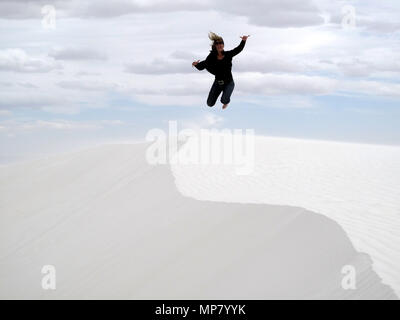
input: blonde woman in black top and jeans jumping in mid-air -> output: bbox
[192,32,250,109]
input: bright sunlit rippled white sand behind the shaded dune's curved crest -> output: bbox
[172,137,400,295]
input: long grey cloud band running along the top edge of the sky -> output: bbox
[0,0,323,28]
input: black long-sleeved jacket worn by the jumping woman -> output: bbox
[195,40,246,82]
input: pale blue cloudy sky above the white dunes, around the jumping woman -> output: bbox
[0,0,400,162]
